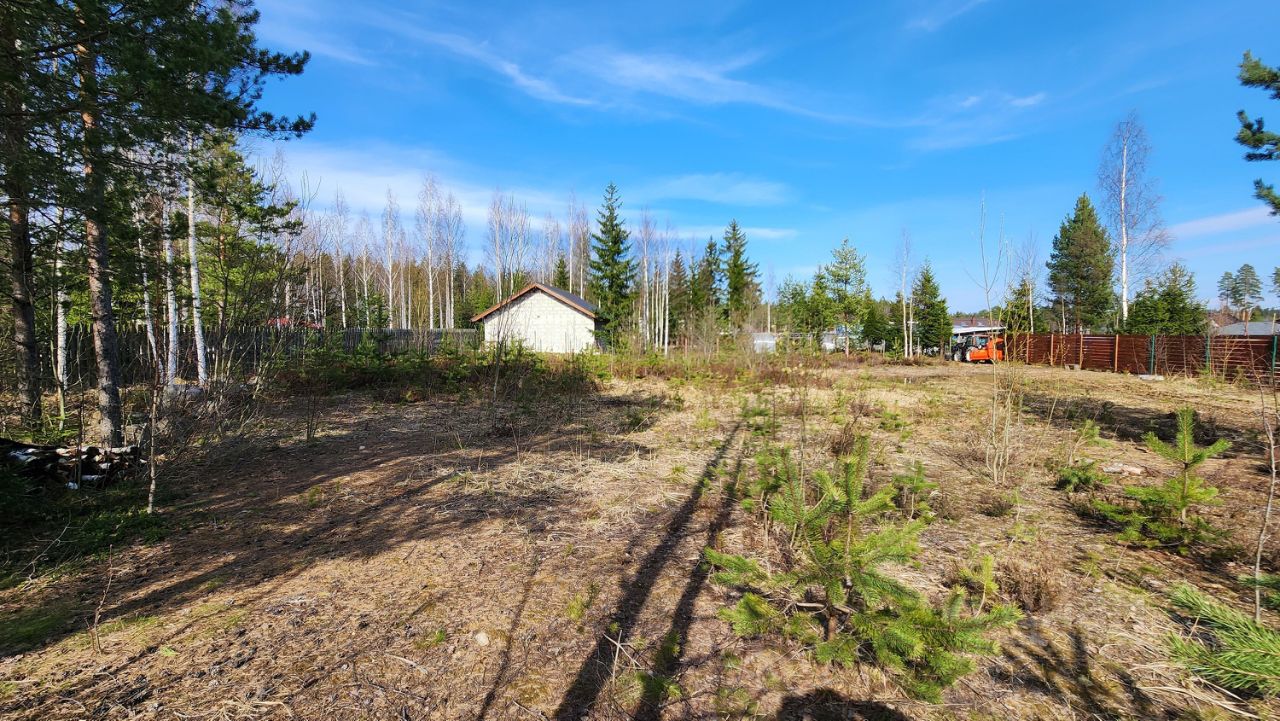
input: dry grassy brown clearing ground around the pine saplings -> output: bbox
[0,364,1280,720]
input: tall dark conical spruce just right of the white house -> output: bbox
[590,183,635,343]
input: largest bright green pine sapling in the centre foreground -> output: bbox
[704,438,1020,701]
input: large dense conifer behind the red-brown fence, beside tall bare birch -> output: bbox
[1047,193,1115,333]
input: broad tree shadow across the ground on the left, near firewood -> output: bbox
[0,386,675,713]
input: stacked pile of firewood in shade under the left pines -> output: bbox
[0,438,146,489]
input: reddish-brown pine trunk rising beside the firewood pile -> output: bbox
[76,29,124,446]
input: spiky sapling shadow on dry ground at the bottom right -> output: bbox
[992,620,1161,720]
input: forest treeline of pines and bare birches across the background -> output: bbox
[0,0,1280,444]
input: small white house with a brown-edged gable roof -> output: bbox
[471,283,596,353]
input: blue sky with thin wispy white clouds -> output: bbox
[259,0,1280,309]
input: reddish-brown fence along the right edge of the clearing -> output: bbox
[1006,333,1280,384]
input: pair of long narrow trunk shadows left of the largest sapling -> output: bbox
[553,421,742,721]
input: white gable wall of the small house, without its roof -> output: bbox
[484,288,595,353]
